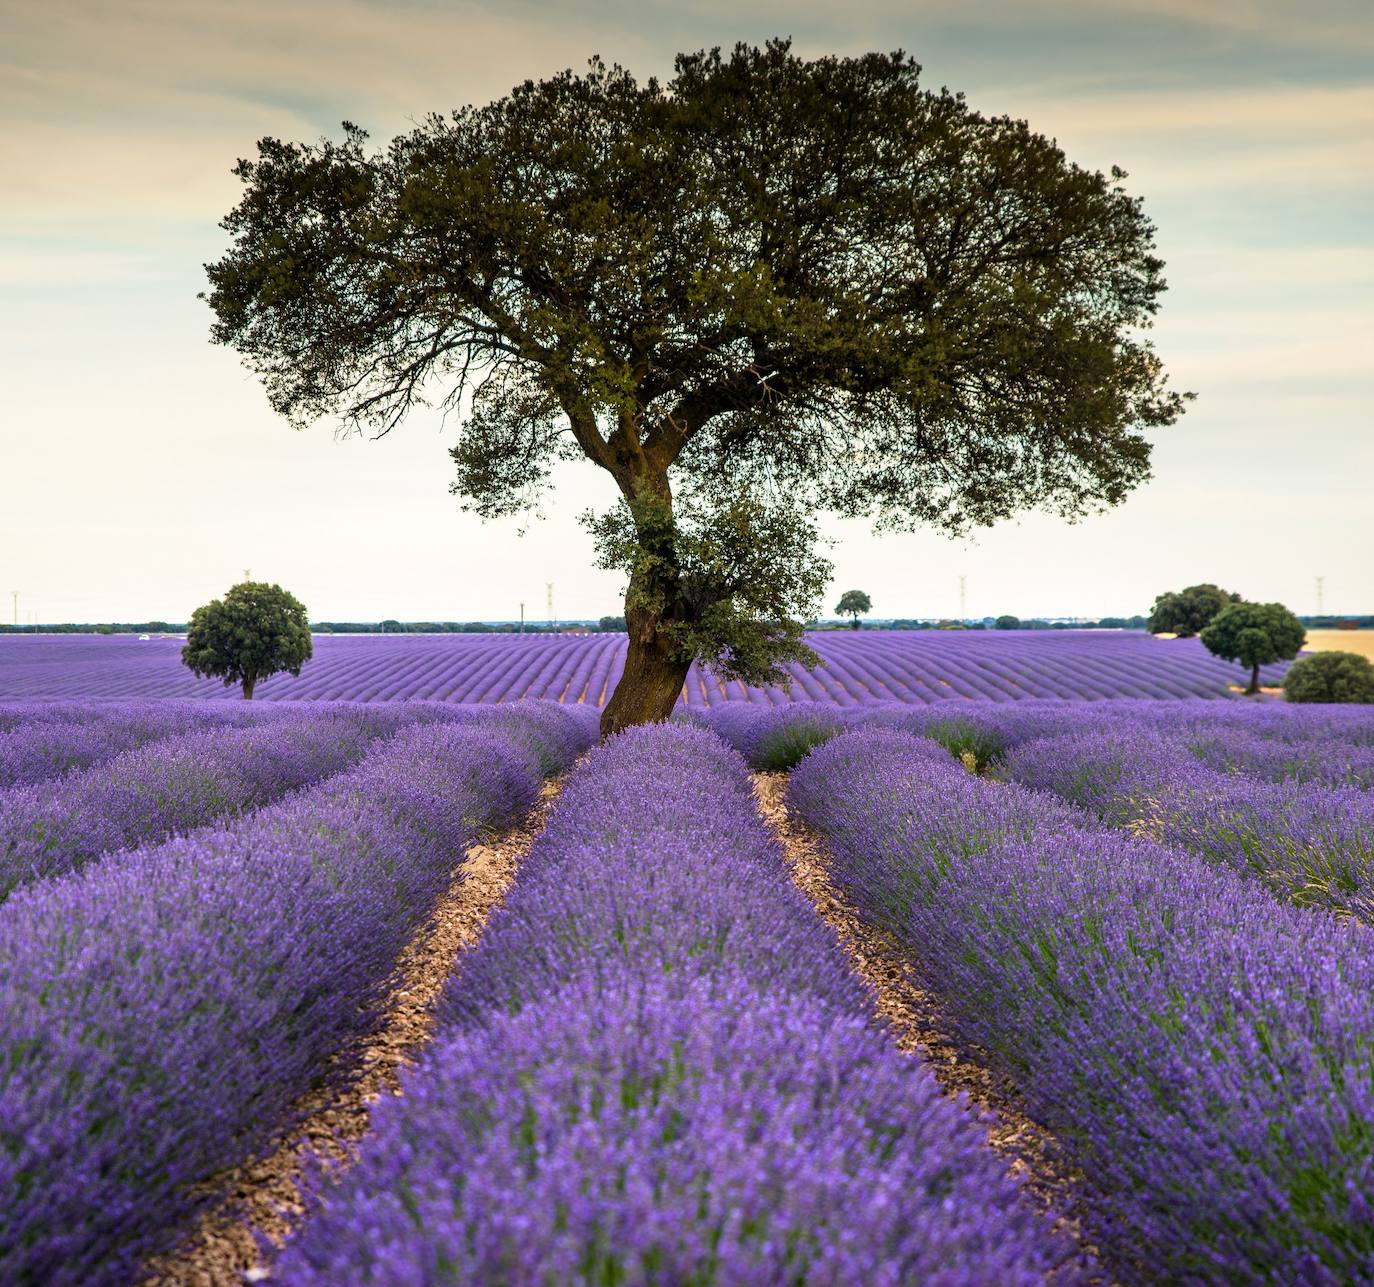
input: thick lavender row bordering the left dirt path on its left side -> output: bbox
[0,707,594,1284]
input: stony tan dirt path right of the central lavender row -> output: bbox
[752,773,1109,1283]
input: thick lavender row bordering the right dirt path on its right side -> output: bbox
[790,729,1374,1283]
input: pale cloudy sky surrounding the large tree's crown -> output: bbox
[0,0,1374,622]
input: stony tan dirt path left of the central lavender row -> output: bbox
[143,775,566,1287]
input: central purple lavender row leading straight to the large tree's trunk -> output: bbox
[265,727,1073,1287]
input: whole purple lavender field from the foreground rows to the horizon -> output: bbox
[0,678,1374,1287]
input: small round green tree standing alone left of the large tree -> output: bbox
[181,581,313,701]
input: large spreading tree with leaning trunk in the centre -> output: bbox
[206,40,1184,732]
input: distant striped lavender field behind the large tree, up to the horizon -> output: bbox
[0,630,1286,706]
